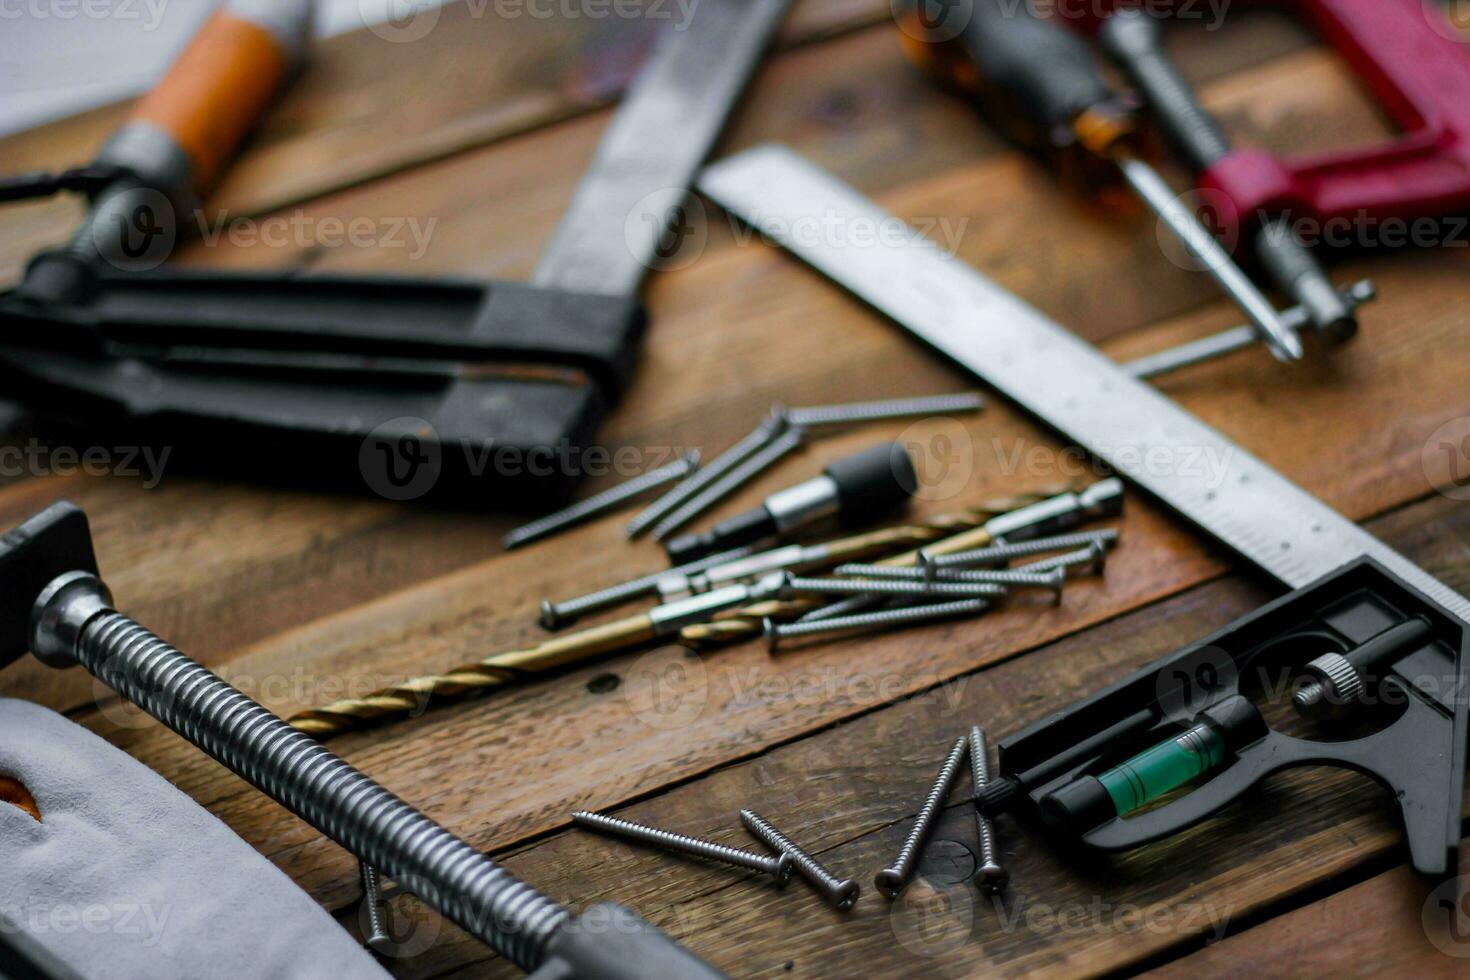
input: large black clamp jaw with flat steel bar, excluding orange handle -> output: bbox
[0,0,785,505]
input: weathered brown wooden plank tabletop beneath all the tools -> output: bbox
[0,0,1470,977]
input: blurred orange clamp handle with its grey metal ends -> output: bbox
[0,0,313,268]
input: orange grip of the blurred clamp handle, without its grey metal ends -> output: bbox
[131,4,309,192]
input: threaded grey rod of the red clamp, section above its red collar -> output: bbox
[1098,10,1230,170]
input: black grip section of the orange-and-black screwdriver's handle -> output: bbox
[957,0,1113,143]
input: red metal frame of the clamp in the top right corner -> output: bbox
[1200,0,1470,235]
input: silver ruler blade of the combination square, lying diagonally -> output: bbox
[698,145,1470,621]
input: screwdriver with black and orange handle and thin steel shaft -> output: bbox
[900,0,1302,361]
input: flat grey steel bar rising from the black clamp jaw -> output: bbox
[531,0,786,295]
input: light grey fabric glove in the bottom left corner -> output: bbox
[0,699,388,980]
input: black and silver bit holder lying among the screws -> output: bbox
[666,442,919,564]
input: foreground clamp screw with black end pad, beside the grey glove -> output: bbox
[0,502,723,980]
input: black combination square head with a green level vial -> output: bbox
[979,557,1470,879]
